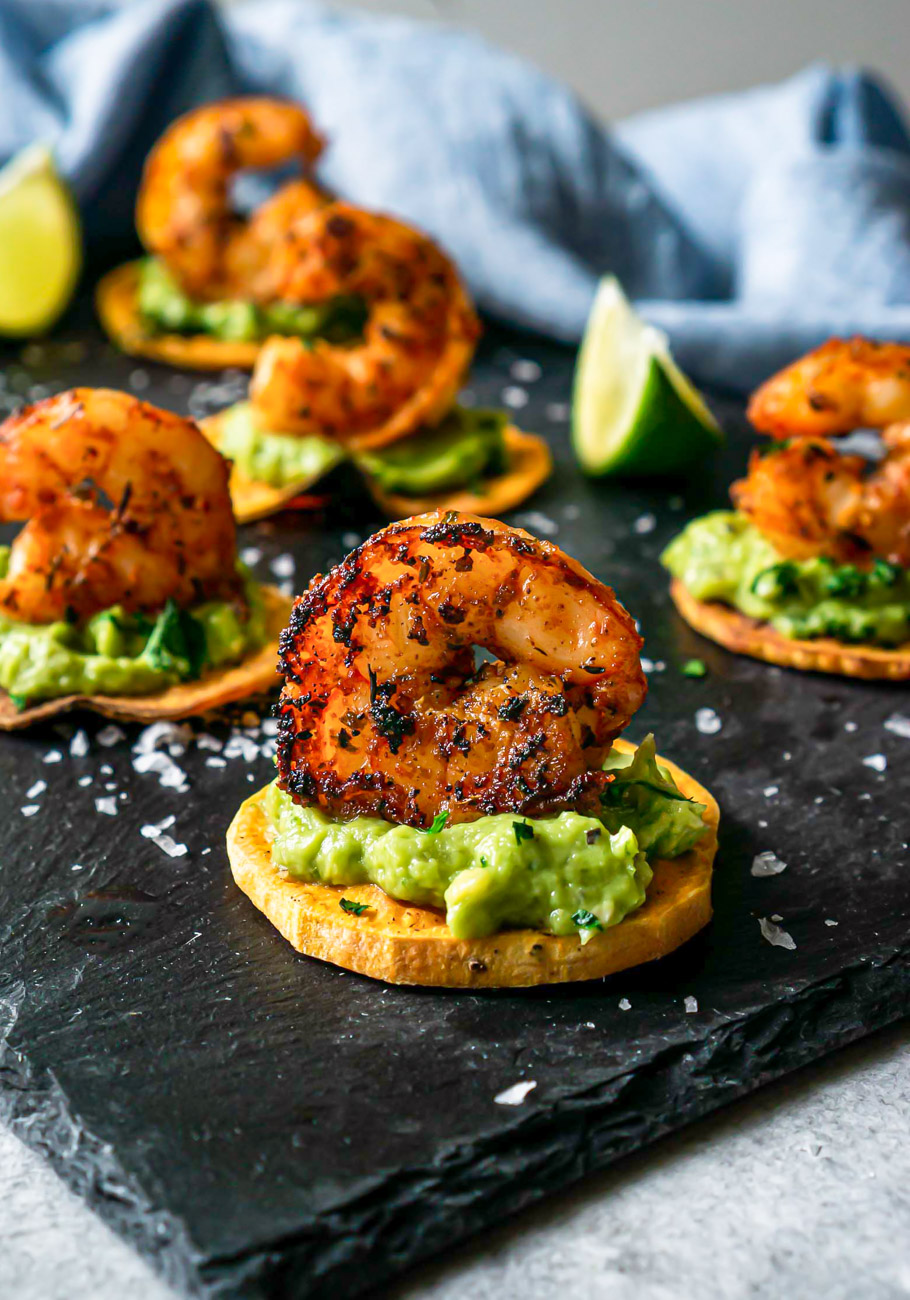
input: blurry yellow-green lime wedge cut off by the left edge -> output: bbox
[0,144,82,335]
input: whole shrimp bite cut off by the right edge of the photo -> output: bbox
[663,338,910,680]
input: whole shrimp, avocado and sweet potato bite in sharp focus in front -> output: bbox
[228,511,719,988]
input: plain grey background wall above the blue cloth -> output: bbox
[314,0,910,118]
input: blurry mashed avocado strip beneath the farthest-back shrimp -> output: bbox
[139,257,365,343]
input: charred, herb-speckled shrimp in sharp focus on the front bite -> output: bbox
[278,511,647,828]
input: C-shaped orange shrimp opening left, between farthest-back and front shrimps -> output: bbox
[250,203,478,447]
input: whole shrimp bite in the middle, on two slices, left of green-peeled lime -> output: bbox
[203,203,551,523]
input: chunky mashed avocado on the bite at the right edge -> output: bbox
[662,510,910,646]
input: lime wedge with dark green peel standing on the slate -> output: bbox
[572,276,722,476]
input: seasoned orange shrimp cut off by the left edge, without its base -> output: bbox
[0,389,239,623]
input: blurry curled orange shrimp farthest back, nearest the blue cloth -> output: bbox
[137,98,325,302]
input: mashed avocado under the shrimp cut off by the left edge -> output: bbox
[0,546,268,709]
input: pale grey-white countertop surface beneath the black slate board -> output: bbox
[0,1023,910,1300]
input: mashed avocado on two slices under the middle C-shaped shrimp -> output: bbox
[218,402,507,495]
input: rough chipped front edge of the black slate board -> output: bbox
[0,948,910,1300]
